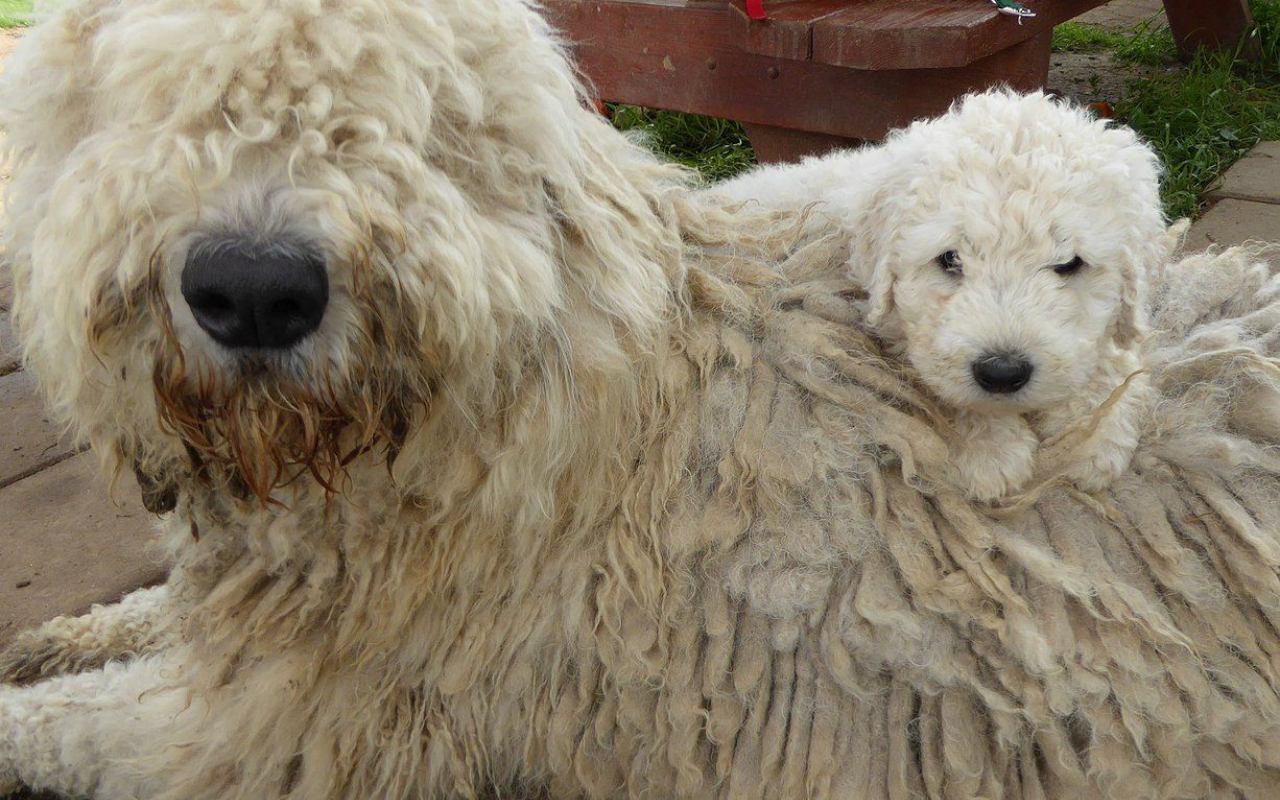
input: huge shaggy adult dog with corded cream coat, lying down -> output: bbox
[0,0,1280,800]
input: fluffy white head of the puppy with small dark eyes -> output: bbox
[854,91,1166,412]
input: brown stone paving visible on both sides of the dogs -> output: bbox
[0,6,1280,645]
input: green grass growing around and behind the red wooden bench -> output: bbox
[613,0,1280,219]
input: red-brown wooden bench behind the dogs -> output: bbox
[543,0,1253,161]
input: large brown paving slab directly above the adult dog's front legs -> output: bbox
[0,453,165,645]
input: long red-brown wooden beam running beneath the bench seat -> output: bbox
[545,0,1048,140]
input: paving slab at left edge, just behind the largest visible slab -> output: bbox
[0,371,73,486]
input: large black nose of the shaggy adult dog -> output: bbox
[182,248,329,348]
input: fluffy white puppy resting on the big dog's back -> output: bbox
[709,91,1169,499]
